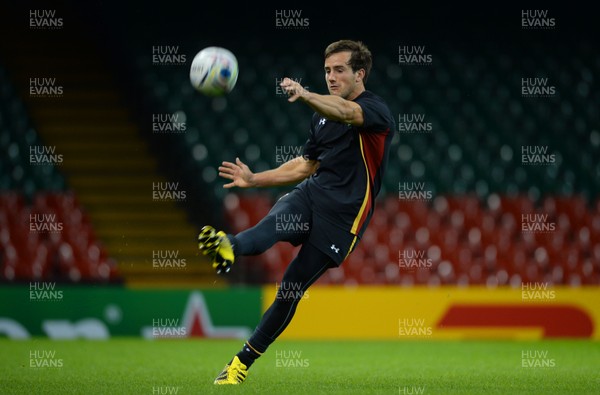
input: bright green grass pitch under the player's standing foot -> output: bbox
[0,338,600,395]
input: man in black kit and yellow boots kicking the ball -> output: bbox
[198,40,395,384]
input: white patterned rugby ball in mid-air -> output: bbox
[190,47,238,96]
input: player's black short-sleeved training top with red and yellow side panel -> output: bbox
[298,91,395,238]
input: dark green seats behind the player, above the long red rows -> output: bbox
[124,34,599,199]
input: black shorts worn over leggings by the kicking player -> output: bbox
[267,188,358,266]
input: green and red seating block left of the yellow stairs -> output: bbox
[0,63,121,283]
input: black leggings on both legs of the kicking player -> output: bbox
[229,192,336,353]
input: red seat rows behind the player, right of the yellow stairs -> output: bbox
[225,194,600,287]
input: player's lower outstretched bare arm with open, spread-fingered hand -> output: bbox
[219,157,319,188]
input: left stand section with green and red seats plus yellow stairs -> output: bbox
[0,4,214,285]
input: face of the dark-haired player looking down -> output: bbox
[325,51,359,99]
